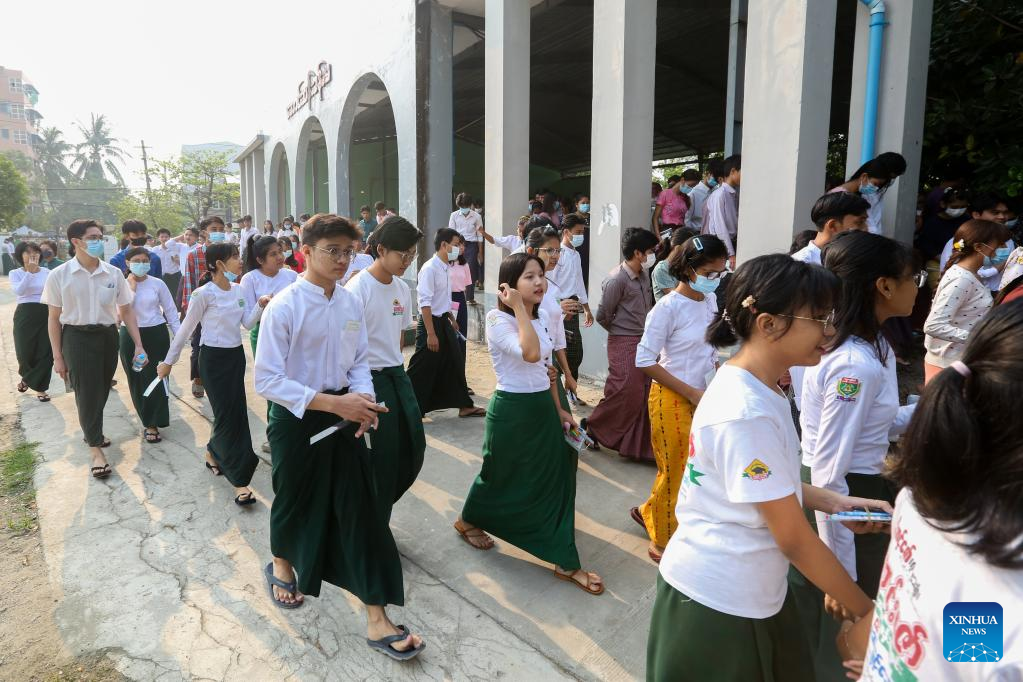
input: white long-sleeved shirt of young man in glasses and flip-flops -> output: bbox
[255,277,375,419]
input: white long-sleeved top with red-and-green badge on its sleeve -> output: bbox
[799,336,916,580]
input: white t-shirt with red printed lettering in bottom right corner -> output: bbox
[860,490,1023,682]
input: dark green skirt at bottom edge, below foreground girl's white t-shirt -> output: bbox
[647,573,814,682]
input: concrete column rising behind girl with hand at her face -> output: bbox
[477,0,530,300]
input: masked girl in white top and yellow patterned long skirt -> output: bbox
[630,236,728,562]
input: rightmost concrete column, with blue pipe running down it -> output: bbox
[845,0,934,242]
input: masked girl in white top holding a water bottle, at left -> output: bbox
[120,246,180,443]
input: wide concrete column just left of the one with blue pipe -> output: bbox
[738,0,836,261]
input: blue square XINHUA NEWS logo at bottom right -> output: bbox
[941,601,1005,663]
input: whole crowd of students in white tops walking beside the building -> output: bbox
[3,152,1023,680]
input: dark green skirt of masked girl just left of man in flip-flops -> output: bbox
[198,346,259,488]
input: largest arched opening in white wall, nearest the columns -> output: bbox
[335,72,400,216]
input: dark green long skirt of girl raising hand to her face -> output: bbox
[461,391,580,571]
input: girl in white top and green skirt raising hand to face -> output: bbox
[454,253,604,595]
